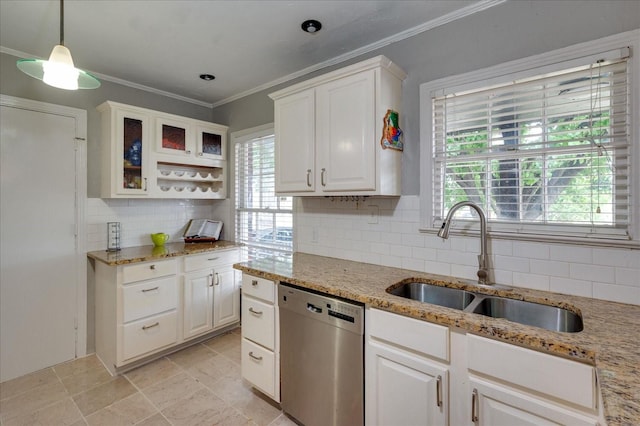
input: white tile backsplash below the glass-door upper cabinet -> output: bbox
[87,198,215,251]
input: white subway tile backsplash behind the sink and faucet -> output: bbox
[294,196,640,305]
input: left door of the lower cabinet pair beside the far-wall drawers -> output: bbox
[184,270,214,339]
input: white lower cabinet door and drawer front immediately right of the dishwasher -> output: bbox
[365,309,449,425]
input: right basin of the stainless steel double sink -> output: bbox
[469,296,583,333]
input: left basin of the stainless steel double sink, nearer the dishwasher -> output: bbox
[387,282,475,310]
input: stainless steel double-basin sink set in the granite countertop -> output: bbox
[387,282,583,333]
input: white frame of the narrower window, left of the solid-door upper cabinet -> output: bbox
[229,123,295,260]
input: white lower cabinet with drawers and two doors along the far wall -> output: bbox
[95,249,240,374]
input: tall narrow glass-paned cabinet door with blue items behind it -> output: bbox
[112,109,151,195]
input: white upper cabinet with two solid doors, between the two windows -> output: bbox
[270,56,405,196]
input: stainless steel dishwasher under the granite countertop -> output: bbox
[278,283,364,426]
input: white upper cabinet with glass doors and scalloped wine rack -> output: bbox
[98,101,227,199]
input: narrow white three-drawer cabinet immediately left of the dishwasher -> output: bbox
[241,274,280,402]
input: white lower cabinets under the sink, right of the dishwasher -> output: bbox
[365,308,605,426]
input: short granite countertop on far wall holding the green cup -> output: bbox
[87,241,242,266]
